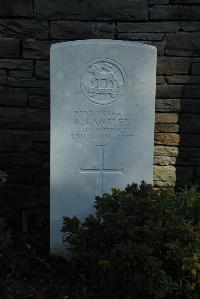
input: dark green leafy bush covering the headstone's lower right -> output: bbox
[63,182,200,299]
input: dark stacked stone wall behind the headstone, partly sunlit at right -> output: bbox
[0,0,200,237]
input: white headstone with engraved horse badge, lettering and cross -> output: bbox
[50,40,156,254]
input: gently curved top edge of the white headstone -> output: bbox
[50,39,157,52]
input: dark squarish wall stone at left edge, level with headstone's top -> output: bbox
[0,38,20,58]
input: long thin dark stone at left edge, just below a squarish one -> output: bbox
[0,59,33,71]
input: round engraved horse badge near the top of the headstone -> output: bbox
[81,59,126,105]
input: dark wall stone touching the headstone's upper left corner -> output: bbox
[23,39,51,59]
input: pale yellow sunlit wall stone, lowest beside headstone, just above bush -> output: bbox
[154,165,176,186]
